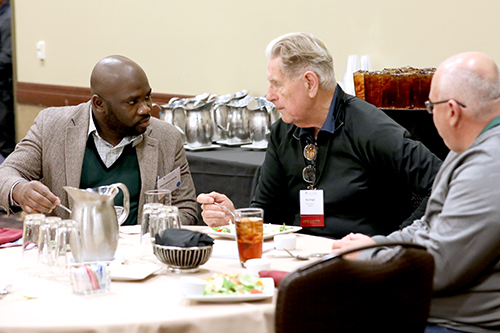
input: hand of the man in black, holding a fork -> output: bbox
[196,192,234,227]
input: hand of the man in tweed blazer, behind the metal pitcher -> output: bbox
[12,180,61,214]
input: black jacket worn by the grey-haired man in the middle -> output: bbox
[251,87,441,238]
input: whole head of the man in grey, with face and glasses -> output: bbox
[429,52,500,154]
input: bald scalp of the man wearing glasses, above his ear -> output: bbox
[433,52,500,118]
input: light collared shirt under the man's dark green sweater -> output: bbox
[88,106,144,168]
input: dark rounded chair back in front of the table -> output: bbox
[275,243,434,333]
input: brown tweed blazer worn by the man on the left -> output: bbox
[0,101,197,224]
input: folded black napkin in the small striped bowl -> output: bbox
[155,229,214,247]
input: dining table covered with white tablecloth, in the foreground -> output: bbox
[0,226,333,333]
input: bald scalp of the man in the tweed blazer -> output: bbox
[90,55,147,99]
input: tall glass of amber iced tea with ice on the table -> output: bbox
[235,208,264,267]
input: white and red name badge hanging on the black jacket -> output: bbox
[300,190,325,227]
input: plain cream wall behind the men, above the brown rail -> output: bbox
[13,0,500,96]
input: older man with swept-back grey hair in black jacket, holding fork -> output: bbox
[198,33,441,238]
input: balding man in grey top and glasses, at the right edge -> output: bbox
[333,52,500,333]
